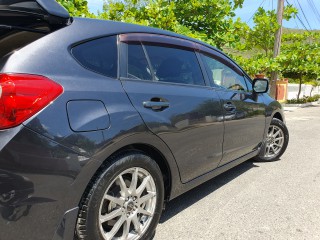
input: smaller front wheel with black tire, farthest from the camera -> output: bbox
[254,118,289,162]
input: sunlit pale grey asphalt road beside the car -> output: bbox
[155,106,320,240]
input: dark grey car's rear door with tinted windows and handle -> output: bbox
[120,34,223,182]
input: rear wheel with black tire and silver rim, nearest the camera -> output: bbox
[75,151,164,240]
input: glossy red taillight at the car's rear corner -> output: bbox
[0,74,63,129]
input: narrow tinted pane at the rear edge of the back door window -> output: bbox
[127,43,152,80]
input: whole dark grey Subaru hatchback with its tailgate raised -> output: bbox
[0,0,289,240]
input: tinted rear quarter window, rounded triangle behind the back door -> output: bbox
[72,36,118,78]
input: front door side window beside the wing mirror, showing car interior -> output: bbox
[201,54,248,91]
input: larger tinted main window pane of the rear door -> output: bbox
[145,45,205,86]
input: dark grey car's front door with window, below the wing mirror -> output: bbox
[201,50,266,166]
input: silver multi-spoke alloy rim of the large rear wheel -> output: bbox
[99,167,157,240]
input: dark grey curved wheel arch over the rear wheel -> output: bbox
[71,133,181,213]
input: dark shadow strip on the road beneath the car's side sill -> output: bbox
[160,160,259,223]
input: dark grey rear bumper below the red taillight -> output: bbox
[0,127,91,240]
